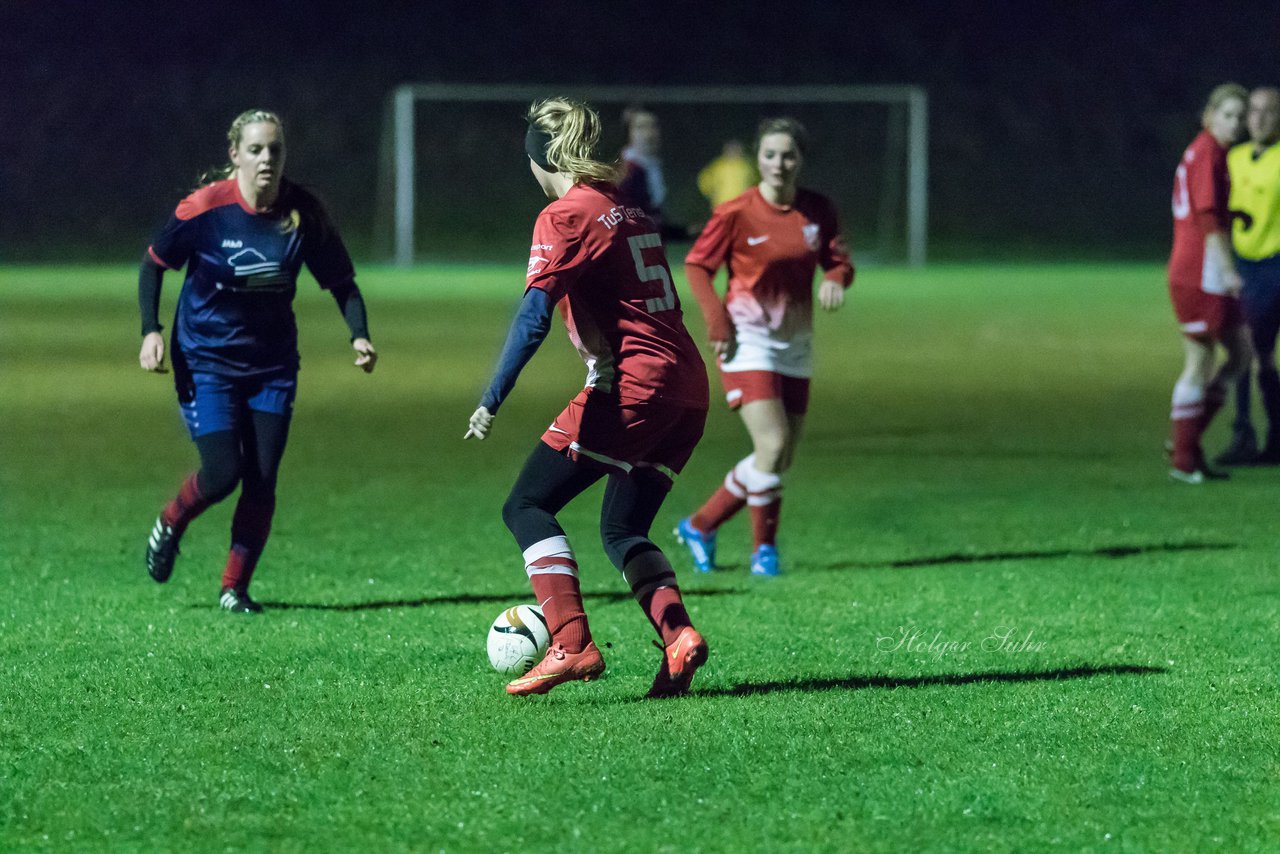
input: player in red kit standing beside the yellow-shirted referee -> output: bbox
[1169,83,1252,484]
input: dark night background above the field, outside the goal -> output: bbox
[0,0,1280,262]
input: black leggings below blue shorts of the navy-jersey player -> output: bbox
[196,411,289,503]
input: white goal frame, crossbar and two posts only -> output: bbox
[392,83,928,266]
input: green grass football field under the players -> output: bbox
[0,264,1280,851]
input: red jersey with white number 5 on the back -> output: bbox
[526,183,708,408]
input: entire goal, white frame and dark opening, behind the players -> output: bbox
[375,83,928,266]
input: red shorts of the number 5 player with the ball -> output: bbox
[543,388,707,480]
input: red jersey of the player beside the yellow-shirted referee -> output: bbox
[1169,131,1231,293]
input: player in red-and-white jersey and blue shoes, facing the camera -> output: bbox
[676,118,854,575]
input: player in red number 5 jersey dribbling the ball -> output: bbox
[463,99,707,697]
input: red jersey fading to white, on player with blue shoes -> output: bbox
[685,187,854,368]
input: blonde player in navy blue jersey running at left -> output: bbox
[138,110,378,613]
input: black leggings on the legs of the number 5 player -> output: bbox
[502,442,671,571]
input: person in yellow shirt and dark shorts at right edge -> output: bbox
[1217,86,1280,466]
